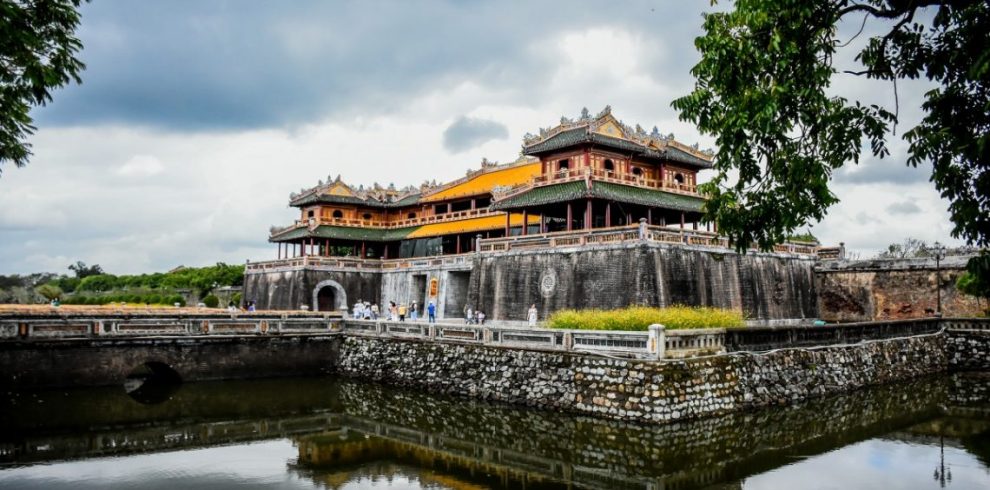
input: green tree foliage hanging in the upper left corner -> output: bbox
[0,0,85,171]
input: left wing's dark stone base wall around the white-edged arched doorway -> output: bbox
[243,269,382,310]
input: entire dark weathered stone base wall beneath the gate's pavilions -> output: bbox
[244,243,818,321]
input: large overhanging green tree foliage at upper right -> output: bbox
[673,0,990,249]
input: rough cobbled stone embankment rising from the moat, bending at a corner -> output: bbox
[338,335,946,422]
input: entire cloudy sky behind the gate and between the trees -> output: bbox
[0,0,954,274]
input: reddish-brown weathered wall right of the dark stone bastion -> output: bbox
[815,257,980,322]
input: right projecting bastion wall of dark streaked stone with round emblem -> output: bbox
[468,243,818,320]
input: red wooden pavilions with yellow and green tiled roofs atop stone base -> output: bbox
[269,107,712,259]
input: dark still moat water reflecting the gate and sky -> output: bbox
[0,375,990,490]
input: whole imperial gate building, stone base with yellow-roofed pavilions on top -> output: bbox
[244,107,843,320]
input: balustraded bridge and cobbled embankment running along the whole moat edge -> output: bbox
[0,315,990,423]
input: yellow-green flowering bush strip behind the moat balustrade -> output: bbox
[547,306,746,331]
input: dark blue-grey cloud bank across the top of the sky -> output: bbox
[27,0,684,130]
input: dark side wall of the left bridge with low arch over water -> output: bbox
[0,334,340,388]
